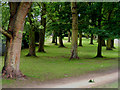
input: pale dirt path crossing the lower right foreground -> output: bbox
[19,69,118,88]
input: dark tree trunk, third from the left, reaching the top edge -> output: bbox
[38,3,46,52]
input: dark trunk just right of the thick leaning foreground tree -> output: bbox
[27,9,36,56]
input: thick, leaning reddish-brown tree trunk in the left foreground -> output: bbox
[2,2,31,78]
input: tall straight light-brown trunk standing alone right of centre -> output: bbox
[70,2,78,59]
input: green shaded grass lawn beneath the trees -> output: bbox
[0,38,118,85]
